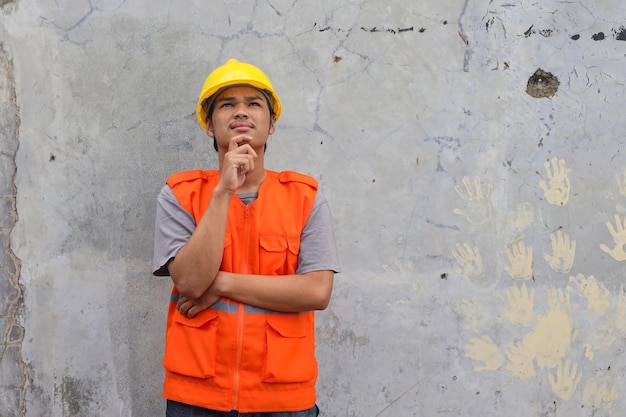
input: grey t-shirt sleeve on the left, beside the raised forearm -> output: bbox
[152,185,196,276]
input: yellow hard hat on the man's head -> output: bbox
[196,58,282,129]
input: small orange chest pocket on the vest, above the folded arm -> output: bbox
[259,234,300,275]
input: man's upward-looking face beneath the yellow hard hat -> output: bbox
[207,86,274,149]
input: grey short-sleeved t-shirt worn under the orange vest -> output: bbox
[152,185,341,276]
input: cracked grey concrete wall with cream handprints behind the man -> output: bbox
[0,0,626,417]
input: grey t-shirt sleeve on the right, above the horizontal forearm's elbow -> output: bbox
[297,190,341,274]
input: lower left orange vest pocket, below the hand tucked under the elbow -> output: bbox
[163,310,217,378]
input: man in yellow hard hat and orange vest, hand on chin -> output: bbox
[153,59,339,417]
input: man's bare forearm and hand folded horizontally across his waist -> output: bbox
[177,270,335,317]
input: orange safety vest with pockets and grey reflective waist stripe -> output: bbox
[163,170,317,413]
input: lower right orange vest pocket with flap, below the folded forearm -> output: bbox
[263,313,317,383]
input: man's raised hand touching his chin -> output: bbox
[220,135,257,193]
